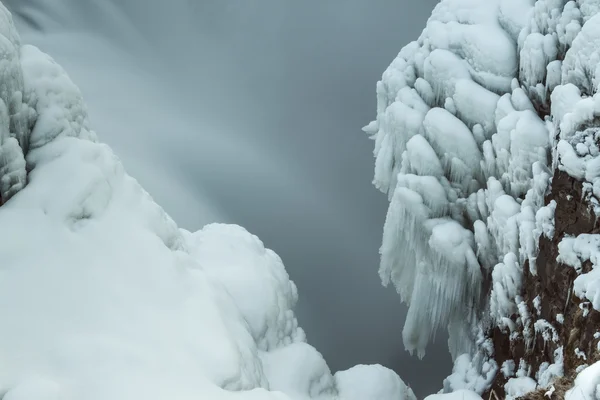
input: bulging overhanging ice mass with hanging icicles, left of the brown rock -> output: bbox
[365,0,556,357]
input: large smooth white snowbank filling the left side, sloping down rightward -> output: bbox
[0,4,414,400]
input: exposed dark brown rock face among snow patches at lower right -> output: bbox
[484,170,600,398]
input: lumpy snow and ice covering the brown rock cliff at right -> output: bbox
[364,0,600,398]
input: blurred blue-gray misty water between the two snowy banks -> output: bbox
[4,0,451,395]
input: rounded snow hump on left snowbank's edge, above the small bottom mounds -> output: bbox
[186,225,305,351]
